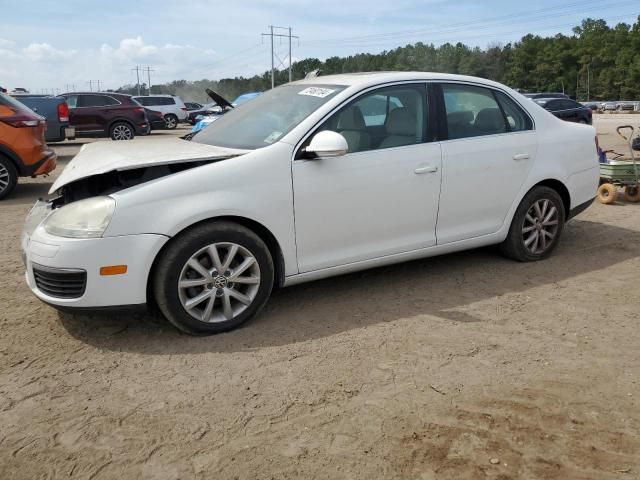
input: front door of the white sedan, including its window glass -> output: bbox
[292,83,441,273]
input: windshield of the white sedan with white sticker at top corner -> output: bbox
[192,85,346,150]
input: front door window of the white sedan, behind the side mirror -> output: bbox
[318,84,427,153]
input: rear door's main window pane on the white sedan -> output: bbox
[442,84,507,139]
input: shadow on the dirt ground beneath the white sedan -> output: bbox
[60,220,640,354]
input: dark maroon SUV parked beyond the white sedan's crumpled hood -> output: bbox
[62,92,149,140]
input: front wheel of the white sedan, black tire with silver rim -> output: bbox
[156,222,274,335]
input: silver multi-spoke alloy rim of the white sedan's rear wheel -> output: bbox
[522,199,560,255]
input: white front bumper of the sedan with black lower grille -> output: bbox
[21,201,169,311]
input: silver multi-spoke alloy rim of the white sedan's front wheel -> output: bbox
[178,242,260,323]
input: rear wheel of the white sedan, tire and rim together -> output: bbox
[500,186,566,262]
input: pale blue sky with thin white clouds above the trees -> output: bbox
[0,0,640,93]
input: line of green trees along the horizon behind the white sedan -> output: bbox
[118,15,640,102]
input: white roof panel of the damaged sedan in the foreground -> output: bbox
[290,72,504,88]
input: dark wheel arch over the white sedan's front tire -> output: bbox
[147,215,285,303]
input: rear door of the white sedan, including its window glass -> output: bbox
[436,83,537,244]
